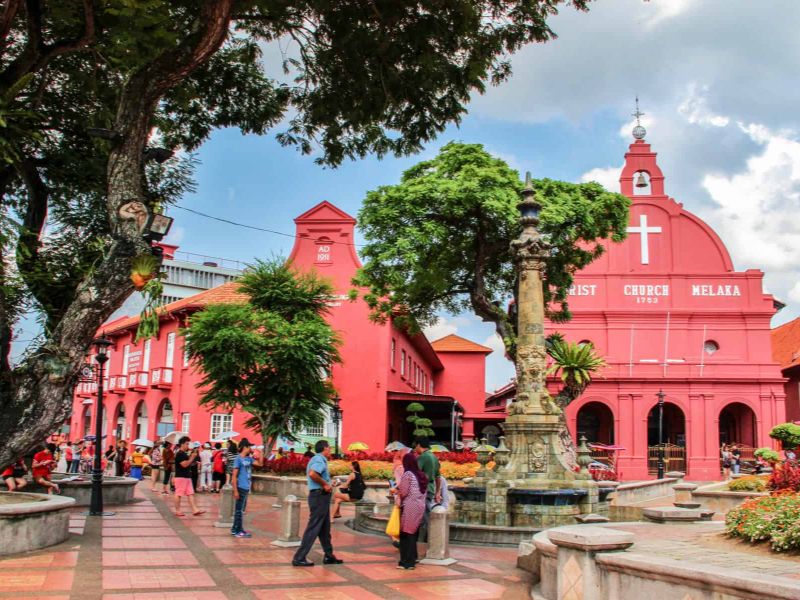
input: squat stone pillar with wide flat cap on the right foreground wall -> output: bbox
[548,525,634,600]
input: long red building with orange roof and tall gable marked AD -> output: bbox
[70,202,492,449]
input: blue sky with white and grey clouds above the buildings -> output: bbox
[25,0,800,390]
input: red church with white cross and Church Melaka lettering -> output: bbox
[484,132,786,480]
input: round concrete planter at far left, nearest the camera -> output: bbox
[0,492,75,556]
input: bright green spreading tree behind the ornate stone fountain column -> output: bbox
[354,142,630,359]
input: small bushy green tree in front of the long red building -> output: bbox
[184,260,341,448]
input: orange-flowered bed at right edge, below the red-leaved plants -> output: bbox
[725,491,800,552]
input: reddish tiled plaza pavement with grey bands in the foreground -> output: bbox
[0,484,530,600]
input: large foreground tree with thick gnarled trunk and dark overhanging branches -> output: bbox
[0,0,587,464]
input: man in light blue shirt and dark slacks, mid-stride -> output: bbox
[292,440,344,567]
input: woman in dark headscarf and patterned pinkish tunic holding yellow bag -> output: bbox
[392,453,424,571]
